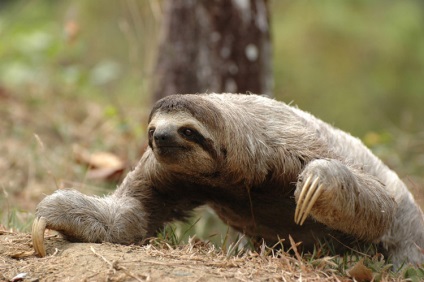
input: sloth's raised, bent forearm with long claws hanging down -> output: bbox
[294,159,397,241]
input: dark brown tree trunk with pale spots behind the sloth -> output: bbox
[154,0,273,100]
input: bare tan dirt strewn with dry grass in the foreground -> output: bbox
[0,231,349,281]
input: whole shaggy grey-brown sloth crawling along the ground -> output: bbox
[33,94,424,265]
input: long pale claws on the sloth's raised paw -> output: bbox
[294,177,323,225]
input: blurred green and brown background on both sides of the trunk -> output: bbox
[0,0,424,238]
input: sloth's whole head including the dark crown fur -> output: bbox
[148,95,225,176]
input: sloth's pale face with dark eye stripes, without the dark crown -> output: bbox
[148,111,217,176]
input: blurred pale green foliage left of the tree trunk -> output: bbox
[0,0,157,102]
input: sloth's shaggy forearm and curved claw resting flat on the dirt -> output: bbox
[32,190,146,256]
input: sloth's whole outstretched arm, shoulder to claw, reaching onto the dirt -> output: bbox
[32,153,198,256]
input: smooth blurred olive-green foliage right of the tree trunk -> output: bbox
[272,0,424,137]
